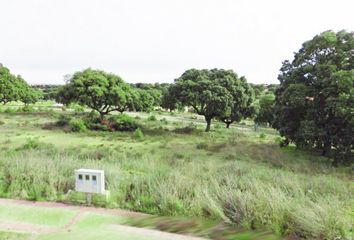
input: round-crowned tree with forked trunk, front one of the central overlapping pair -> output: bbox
[171,69,233,132]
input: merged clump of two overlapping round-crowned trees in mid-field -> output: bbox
[170,69,253,131]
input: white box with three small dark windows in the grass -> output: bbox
[75,168,106,194]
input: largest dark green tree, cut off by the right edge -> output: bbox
[274,31,354,164]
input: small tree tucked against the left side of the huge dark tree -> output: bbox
[255,93,275,126]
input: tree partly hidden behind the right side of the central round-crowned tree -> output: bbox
[218,75,254,128]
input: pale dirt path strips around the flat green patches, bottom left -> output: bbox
[0,198,202,240]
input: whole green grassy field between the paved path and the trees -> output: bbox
[0,102,354,239]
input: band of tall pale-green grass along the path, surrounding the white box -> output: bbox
[0,141,354,239]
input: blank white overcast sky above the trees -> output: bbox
[0,0,354,84]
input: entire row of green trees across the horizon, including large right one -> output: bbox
[0,31,354,164]
